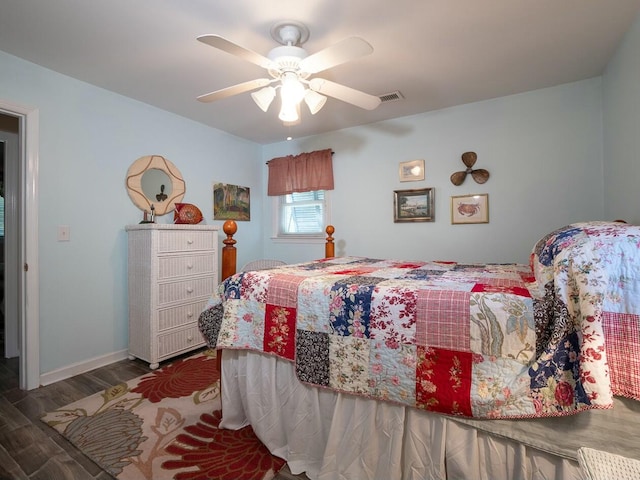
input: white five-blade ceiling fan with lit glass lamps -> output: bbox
[197,20,381,125]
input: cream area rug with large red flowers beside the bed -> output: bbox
[42,350,285,480]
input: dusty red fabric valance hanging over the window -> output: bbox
[267,149,333,196]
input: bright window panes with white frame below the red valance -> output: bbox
[275,190,329,238]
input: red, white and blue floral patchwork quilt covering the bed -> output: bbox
[200,222,640,418]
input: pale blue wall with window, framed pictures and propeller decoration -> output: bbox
[263,78,604,263]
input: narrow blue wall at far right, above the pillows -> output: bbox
[603,10,640,221]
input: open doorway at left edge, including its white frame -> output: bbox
[0,100,40,390]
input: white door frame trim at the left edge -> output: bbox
[0,99,40,390]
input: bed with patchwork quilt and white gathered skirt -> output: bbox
[199,222,640,479]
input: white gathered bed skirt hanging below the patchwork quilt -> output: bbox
[220,350,582,480]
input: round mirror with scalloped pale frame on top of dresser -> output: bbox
[125,155,186,215]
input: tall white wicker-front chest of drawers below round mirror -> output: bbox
[125,223,218,369]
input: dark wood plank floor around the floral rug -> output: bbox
[0,338,307,480]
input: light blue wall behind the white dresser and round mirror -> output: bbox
[0,52,262,373]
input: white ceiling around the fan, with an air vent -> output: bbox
[0,0,640,144]
